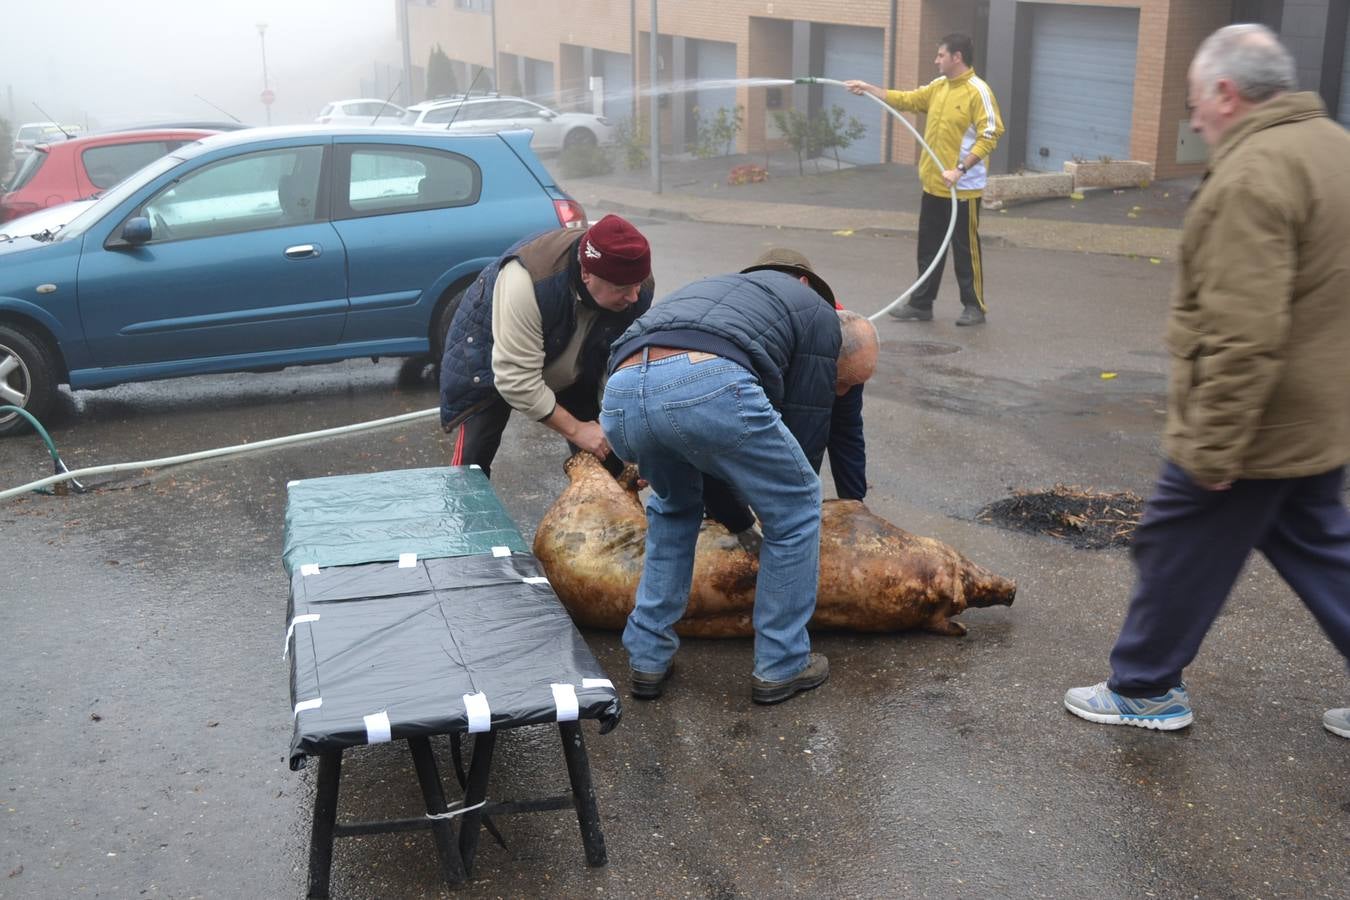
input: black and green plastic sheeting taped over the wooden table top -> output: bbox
[286,470,621,769]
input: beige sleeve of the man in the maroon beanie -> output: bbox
[493,259,556,422]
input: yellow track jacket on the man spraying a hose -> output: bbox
[886,69,1003,200]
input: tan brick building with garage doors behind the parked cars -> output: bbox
[396,0,1350,178]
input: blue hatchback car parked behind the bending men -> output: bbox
[0,127,586,434]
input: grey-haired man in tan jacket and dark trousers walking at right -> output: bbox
[1064,24,1350,738]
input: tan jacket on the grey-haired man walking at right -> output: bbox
[1164,93,1350,483]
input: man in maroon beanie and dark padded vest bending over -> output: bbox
[440,216,655,475]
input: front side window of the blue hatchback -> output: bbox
[142,147,324,242]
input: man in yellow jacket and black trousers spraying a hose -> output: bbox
[844,34,1003,325]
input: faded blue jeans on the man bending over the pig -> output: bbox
[599,355,821,681]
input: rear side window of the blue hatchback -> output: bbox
[344,146,482,219]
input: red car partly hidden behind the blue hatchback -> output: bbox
[0,128,216,223]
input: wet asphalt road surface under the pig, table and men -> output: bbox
[0,219,1350,899]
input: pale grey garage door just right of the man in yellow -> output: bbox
[1025,4,1139,171]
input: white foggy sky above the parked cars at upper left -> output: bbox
[0,0,400,128]
